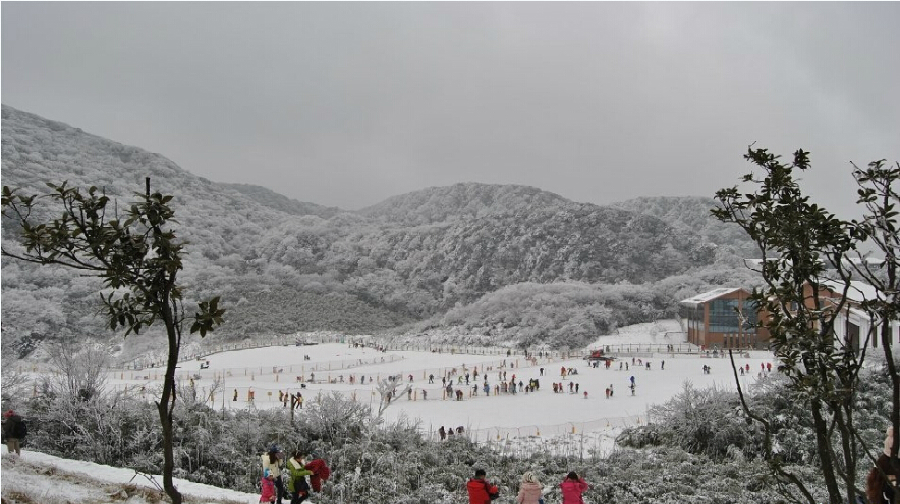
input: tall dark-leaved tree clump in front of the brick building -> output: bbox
[712,147,900,504]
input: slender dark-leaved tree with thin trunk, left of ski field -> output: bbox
[2,178,224,504]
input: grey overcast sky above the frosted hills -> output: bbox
[0,2,900,216]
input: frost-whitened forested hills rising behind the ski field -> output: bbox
[2,106,752,354]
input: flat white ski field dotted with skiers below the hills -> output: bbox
[98,320,774,441]
